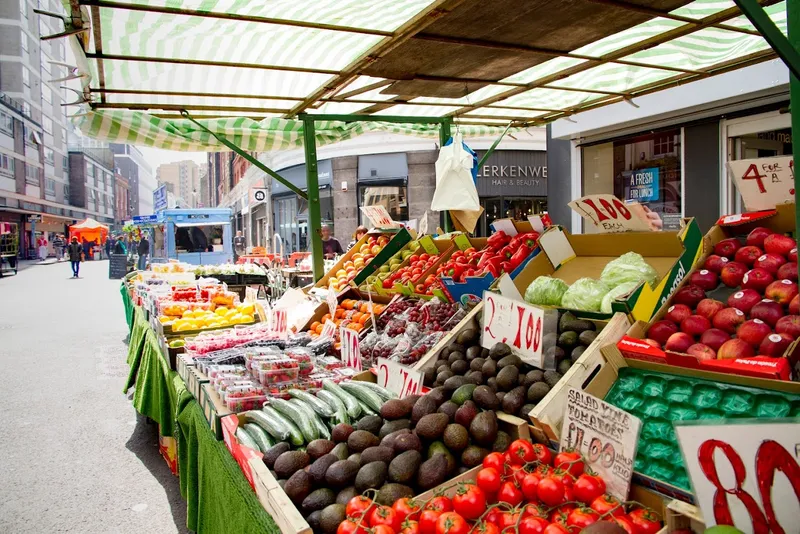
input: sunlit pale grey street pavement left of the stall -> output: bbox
[0,261,188,534]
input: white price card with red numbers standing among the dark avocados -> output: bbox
[481,291,544,367]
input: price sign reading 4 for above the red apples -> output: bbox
[728,156,794,211]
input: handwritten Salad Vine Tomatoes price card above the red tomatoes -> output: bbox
[560,387,642,501]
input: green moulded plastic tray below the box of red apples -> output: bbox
[605,367,800,492]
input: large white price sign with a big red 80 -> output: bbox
[675,419,800,533]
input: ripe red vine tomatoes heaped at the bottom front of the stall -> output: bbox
[340,450,662,534]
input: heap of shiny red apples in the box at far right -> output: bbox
[647,224,800,366]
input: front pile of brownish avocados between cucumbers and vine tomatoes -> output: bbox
[264,382,512,534]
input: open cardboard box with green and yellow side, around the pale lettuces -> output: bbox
[510,219,704,321]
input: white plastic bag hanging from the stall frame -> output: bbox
[431,132,481,211]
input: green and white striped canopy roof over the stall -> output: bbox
[62,0,787,151]
